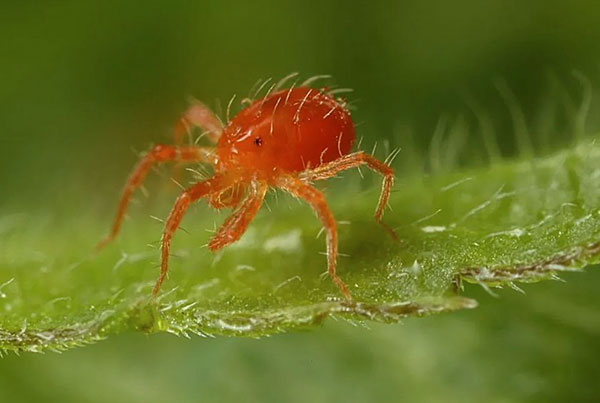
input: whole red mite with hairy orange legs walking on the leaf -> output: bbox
[99,80,395,299]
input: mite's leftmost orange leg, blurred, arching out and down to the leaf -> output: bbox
[97,145,216,249]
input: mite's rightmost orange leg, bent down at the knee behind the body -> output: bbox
[300,151,398,240]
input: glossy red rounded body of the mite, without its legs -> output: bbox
[217,88,354,174]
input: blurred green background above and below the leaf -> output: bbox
[0,0,600,402]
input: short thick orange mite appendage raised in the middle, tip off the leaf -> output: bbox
[208,181,268,251]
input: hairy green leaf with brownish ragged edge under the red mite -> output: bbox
[0,143,600,351]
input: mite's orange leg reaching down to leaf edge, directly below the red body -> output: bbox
[278,176,352,300]
